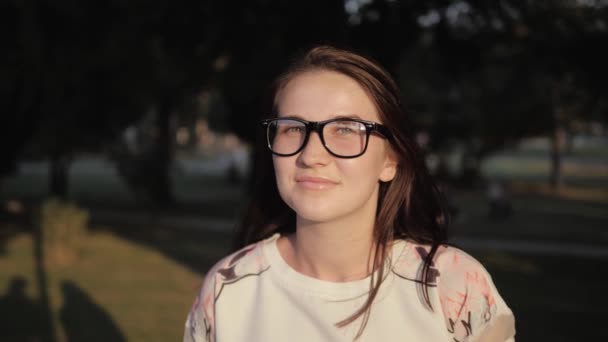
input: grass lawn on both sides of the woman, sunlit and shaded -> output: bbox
[0,198,608,342]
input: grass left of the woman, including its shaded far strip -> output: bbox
[0,224,233,342]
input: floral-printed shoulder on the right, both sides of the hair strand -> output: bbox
[393,240,515,342]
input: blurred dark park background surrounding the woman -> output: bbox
[0,0,608,342]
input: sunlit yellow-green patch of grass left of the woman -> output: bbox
[0,231,214,341]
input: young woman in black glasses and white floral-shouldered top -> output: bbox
[184,46,515,342]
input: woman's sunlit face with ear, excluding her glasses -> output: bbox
[273,71,396,222]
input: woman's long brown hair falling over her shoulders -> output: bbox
[235,46,448,339]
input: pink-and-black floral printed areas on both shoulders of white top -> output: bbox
[184,240,515,342]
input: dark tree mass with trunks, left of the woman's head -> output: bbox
[2,1,224,203]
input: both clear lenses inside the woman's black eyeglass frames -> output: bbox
[268,119,367,157]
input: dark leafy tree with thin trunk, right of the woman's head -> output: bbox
[354,0,608,186]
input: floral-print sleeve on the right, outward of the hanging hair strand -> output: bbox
[436,247,515,342]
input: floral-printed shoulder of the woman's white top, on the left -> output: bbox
[184,236,269,341]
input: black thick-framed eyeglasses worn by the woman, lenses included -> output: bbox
[261,117,391,158]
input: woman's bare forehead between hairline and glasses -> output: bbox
[277,70,379,121]
